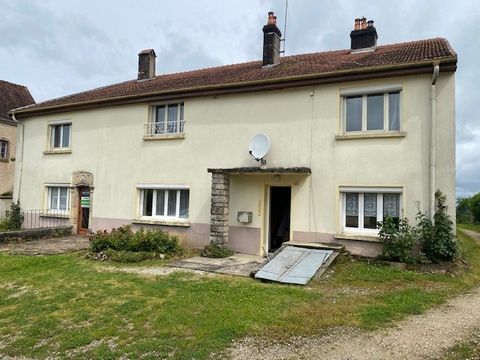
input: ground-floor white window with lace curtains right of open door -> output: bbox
[340,188,402,236]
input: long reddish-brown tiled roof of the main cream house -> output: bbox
[14,38,456,114]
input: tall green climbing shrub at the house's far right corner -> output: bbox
[417,190,457,263]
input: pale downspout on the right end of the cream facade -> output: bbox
[430,62,440,221]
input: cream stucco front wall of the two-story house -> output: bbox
[16,74,455,253]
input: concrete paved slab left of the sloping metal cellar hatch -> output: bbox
[169,254,265,276]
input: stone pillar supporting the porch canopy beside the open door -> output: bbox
[210,172,230,245]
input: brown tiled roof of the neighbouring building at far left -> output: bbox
[0,80,35,124]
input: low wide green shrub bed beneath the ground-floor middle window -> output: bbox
[90,225,183,255]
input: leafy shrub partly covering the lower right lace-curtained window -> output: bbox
[378,216,417,263]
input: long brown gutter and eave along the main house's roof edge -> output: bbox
[10,55,457,118]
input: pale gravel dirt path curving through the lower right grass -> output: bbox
[227,230,480,360]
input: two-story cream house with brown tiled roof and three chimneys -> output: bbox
[9,13,457,255]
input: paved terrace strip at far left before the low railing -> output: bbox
[0,235,89,255]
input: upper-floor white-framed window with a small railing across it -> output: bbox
[147,102,184,135]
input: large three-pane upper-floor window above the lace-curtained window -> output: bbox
[341,86,402,133]
